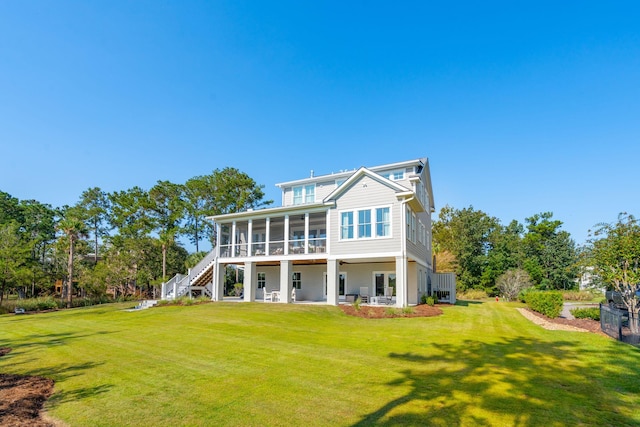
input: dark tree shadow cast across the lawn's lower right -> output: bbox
[353,337,640,427]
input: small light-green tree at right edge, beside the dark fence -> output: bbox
[589,213,640,335]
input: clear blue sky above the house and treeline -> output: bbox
[0,0,640,251]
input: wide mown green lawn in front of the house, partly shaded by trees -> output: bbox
[0,302,640,427]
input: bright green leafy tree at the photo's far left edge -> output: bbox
[0,221,31,303]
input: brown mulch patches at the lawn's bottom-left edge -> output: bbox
[0,347,55,427]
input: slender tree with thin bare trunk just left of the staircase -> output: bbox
[149,181,185,281]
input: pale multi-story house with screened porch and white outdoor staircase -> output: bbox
[162,158,455,307]
